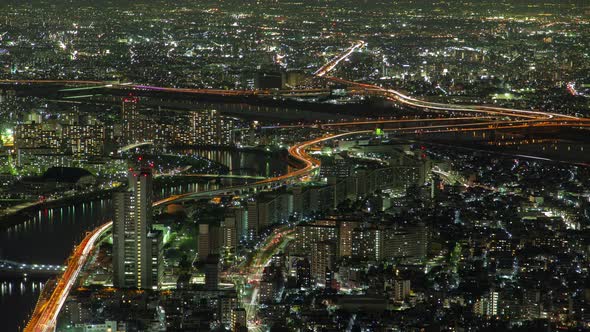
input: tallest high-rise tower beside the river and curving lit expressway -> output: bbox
[113,169,162,289]
